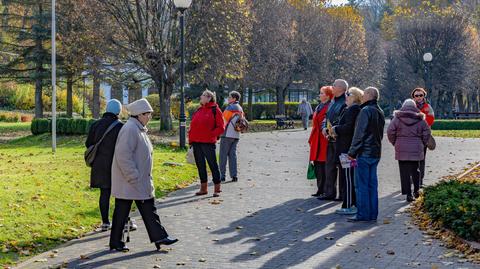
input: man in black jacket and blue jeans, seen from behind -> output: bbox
[348,87,385,222]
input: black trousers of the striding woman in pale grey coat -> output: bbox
[110,198,168,248]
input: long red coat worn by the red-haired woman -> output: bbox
[308,104,329,162]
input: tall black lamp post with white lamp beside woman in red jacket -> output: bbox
[173,0,192,148]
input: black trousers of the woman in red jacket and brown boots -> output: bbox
[192,143,221,184]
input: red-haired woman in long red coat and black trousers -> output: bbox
[308,86,333,197]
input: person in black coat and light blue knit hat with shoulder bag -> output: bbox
[85,99,123,231]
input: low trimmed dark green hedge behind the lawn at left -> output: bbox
[31,118,95,135]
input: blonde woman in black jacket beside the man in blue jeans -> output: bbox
[333,87,363,215]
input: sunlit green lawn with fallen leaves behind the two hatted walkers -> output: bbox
[0,133,196,267]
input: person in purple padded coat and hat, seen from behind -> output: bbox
[387,99,431,202]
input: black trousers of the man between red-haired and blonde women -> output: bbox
[325,142,343,199]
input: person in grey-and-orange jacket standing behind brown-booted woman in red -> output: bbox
[220,91,243,182]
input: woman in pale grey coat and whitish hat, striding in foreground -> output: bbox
[110,99,178,252]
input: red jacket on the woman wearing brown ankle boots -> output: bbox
[188,102,225,144]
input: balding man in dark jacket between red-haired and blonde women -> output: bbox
[318,79,348,200]
